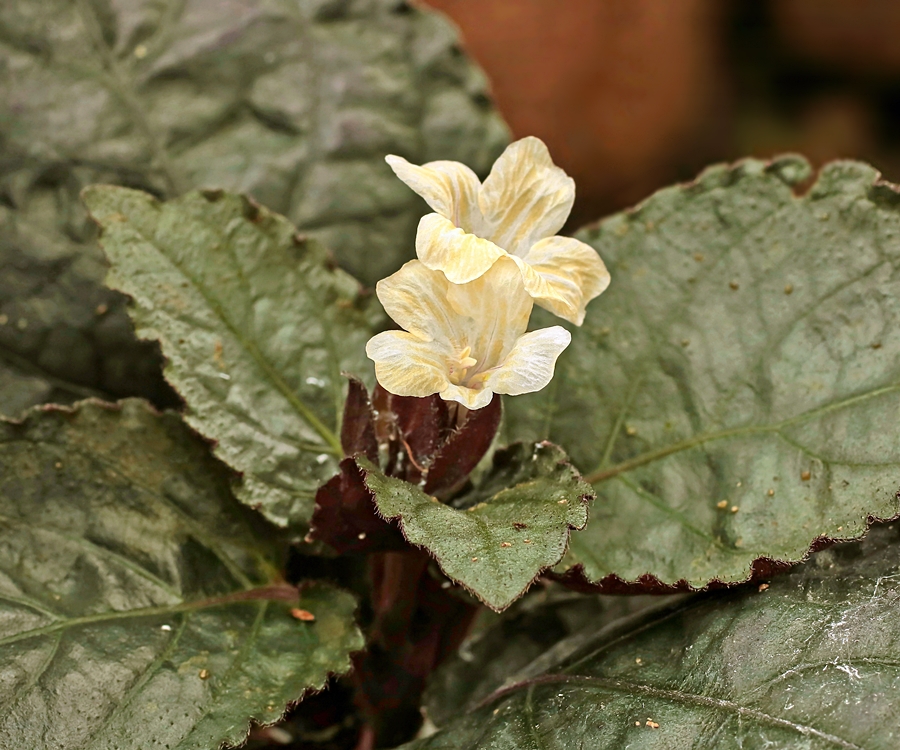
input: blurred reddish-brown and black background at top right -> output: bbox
[422,0,900,225]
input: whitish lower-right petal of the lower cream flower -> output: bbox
[484,326,572,396]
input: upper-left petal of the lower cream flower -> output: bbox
[375,260,459,341]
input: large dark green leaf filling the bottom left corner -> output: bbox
[0,401,362,750]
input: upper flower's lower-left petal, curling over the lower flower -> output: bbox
[416,214,506,284]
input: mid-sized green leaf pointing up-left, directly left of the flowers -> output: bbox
[84,186,375,525]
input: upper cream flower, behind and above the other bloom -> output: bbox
[386,137,609,325]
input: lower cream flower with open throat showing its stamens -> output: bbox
[366,258,572,409]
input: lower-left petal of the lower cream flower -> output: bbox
[366,331,450,398]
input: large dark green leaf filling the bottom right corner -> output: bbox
[405,528,900,750]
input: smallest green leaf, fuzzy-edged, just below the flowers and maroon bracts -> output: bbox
[358,443,593,611]
